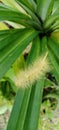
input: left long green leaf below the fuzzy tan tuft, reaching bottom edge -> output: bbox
[7,89,29,130]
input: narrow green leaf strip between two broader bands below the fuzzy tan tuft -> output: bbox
[15,88,31,130]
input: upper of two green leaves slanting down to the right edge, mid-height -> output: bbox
[48,39,59,60]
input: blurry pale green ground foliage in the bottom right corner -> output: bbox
[39,100,59,130]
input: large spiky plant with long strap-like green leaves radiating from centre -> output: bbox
[0,0,59,130]
